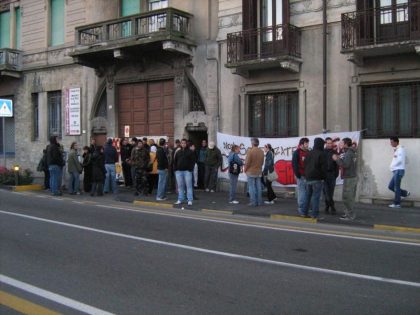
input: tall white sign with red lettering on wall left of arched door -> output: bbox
[66,88,81,136]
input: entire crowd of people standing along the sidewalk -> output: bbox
[38,136,410,220]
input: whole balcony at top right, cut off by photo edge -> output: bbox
[341,3,420,61]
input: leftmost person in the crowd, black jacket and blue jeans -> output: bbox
[47,136,64,196]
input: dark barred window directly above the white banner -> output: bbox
[249,92,299,137]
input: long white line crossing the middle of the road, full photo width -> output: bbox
[0,210,420,288]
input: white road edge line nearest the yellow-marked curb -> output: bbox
[94,205,420,246]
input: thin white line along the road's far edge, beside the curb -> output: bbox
[95,205,420,247]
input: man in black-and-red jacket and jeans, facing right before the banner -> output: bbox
[292,138,309,215]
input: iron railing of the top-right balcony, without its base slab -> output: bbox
[341,3,420,50]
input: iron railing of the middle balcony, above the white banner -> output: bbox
[227,24,301,65]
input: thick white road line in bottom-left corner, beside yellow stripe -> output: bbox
[0,274,113,315]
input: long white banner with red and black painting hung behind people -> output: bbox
[217,131,360,186]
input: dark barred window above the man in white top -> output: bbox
[362,82,420,138]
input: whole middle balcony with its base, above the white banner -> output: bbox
[225,24,302,76]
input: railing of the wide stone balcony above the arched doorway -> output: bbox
[76,8,192,45]
